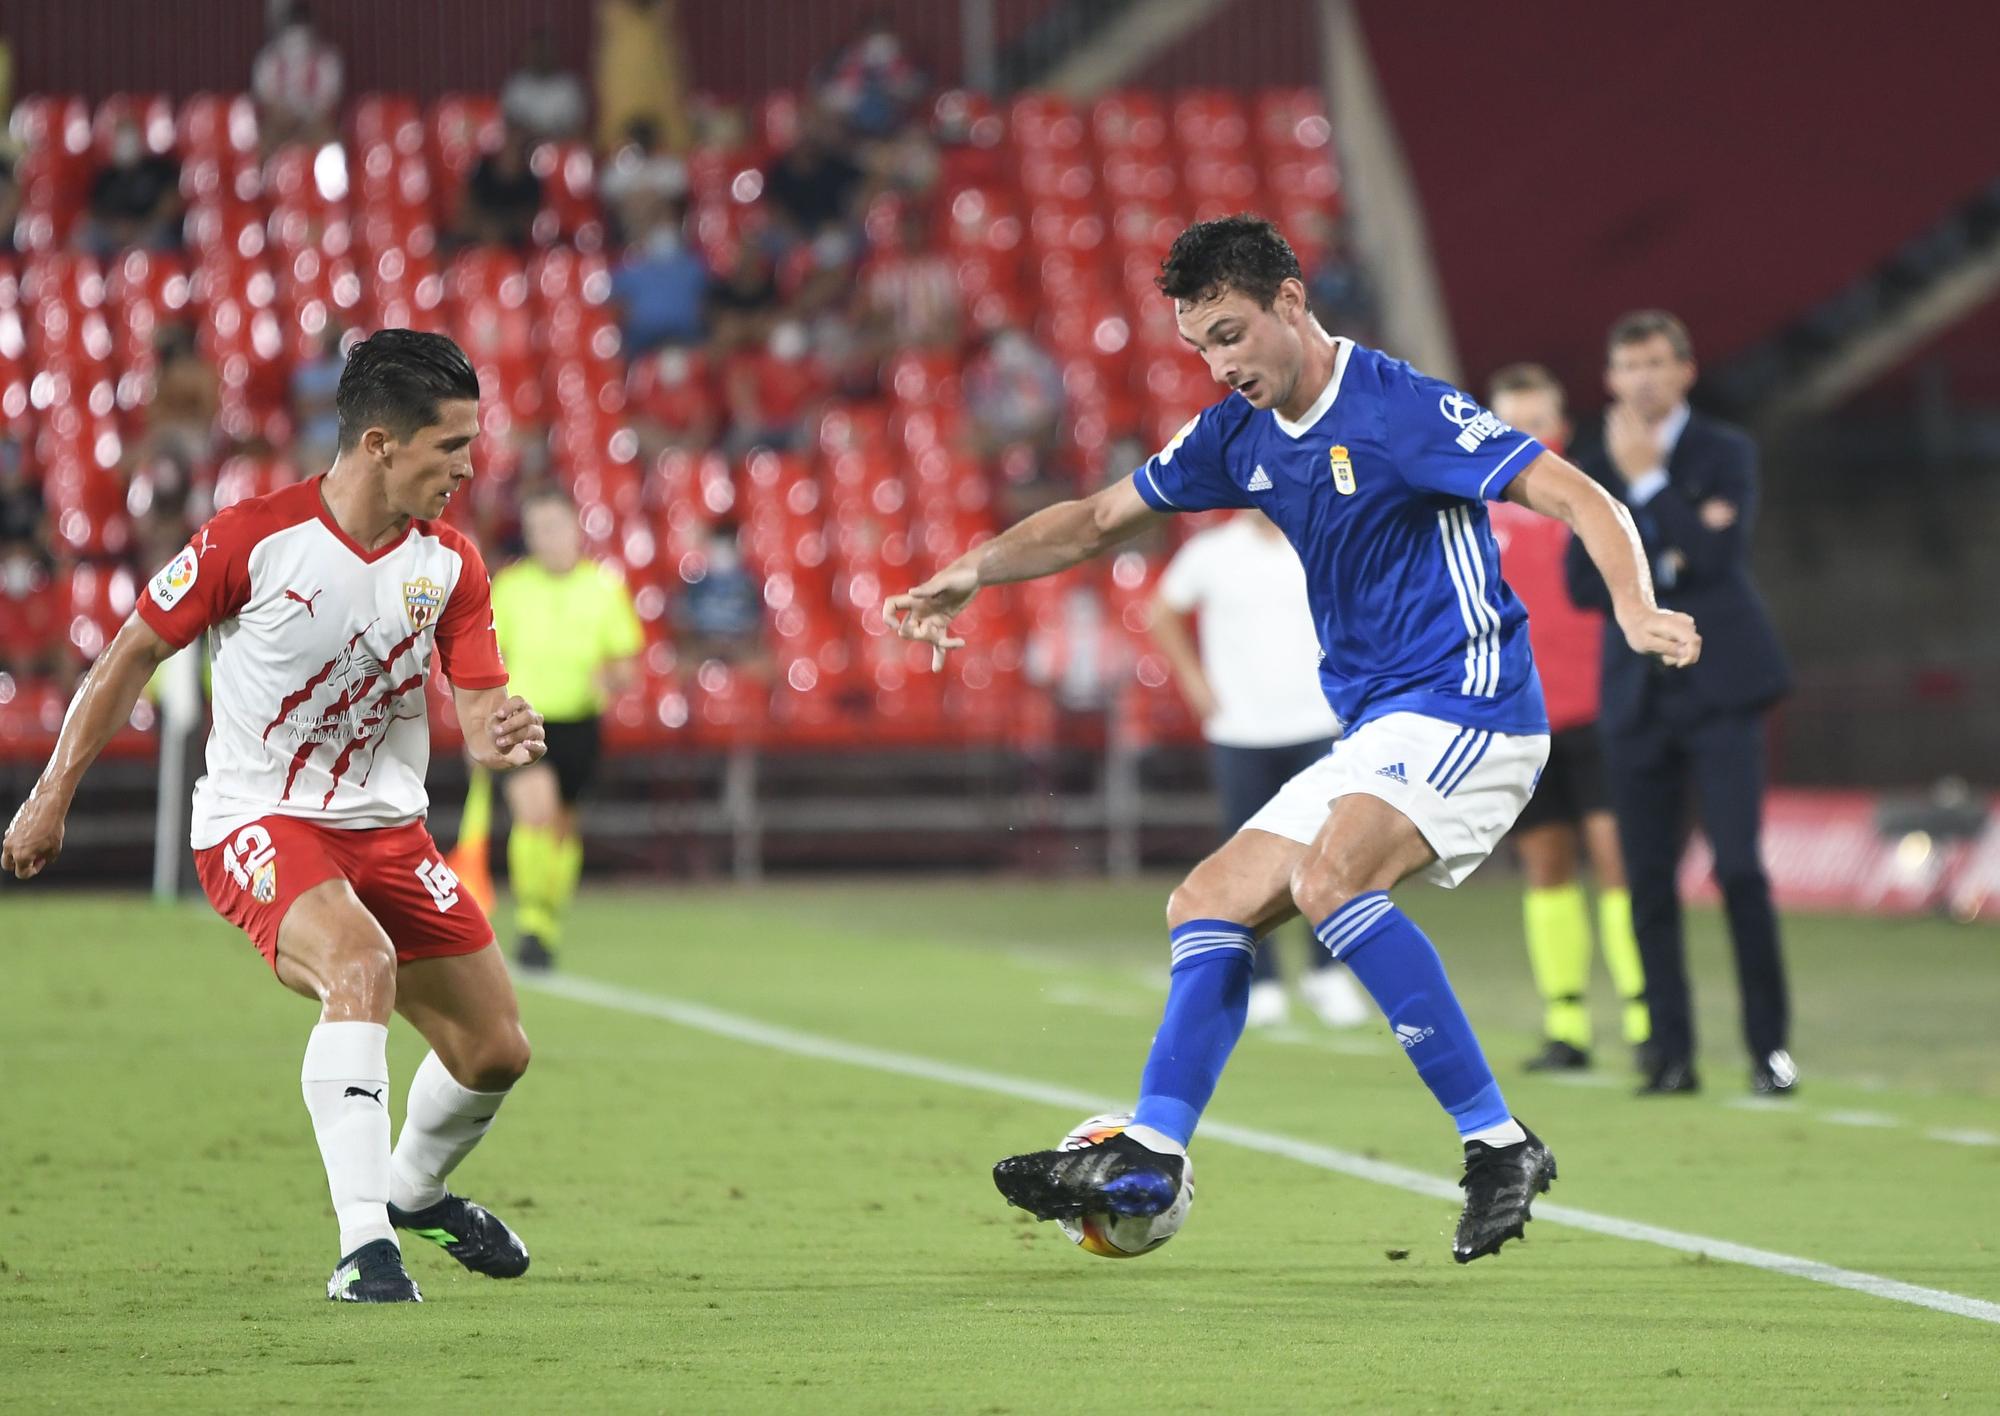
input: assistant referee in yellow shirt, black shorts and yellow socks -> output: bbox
[456,488,646,968]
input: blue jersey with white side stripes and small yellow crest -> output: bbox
[1132,340,1548,732]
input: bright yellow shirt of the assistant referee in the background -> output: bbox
[494,558,646,722]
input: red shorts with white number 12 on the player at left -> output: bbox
[194,816,494,968]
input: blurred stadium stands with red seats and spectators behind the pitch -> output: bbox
[0,0,2000,914]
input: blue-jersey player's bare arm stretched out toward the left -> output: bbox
[882,478,1160,670]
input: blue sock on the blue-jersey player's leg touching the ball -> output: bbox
[1132,920,1256,1146]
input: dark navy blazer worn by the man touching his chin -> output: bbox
[1566,414,1790,732]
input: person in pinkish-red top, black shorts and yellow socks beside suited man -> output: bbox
[1486,364,1652,1072]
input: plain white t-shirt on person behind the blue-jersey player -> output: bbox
[1160,516,1338,748]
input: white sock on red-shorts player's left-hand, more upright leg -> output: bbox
[298,1022,396,1258]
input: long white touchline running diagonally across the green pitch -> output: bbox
[514,974,2000,1324]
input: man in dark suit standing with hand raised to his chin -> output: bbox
[1566,310,1798,1096]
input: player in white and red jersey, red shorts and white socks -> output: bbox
[0,330,544,1302]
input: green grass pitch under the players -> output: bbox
[0,880,2000,1416]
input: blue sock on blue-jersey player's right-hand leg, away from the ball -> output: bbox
[1320,890,1516,1140]
